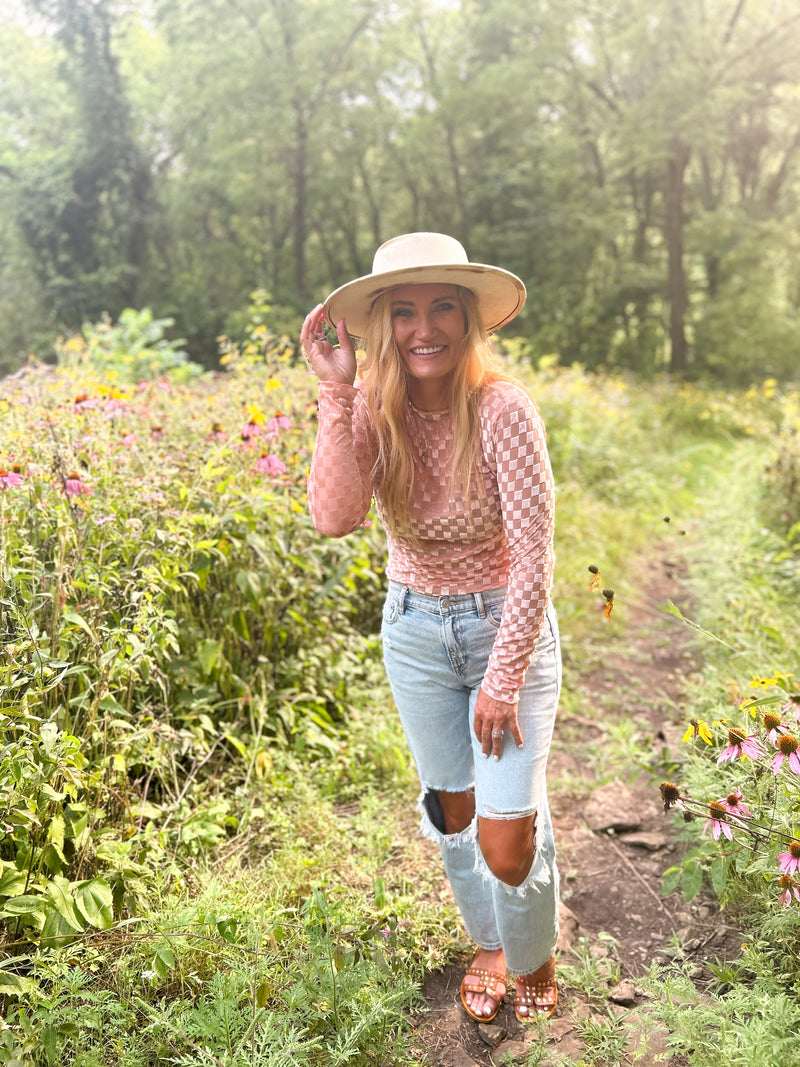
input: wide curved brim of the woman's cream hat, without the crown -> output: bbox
[324,264,526,337]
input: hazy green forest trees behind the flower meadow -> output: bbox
[0,0,800,382]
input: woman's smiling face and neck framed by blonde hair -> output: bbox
[391,282,466,411]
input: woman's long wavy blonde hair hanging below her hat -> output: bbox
[361,285,507,540]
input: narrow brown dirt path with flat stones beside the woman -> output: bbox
[407,558,733,1067]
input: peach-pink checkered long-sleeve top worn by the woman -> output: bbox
[308,382,555,701]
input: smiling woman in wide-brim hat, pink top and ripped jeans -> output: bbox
[301,234,560,1022]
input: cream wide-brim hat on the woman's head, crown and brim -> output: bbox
[324,234,526,337]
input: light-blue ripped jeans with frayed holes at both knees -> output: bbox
[381,582,561,974]
